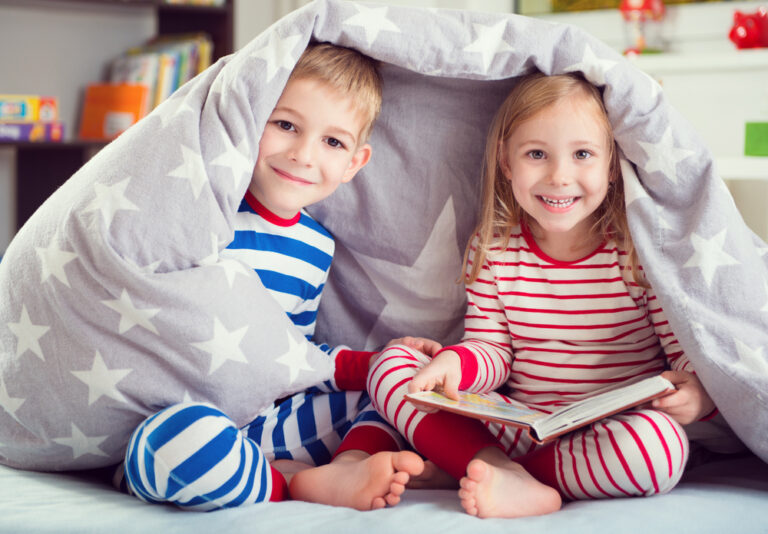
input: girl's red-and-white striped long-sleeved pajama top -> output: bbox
[453,227,693,411]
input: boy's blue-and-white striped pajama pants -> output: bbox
[124,391,396,511]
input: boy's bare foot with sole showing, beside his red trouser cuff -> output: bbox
[289,451,424,510]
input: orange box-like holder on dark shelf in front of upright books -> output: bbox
[80,83,147,140]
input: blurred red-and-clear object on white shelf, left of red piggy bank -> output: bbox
[619,0,665,54]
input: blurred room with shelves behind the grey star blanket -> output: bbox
[0,0,768,256]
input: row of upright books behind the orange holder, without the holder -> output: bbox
[109,33,213,113]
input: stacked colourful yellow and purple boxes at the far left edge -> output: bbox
[0,94,64,142]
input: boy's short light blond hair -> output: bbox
[289,42,382,144]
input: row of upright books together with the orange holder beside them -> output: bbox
[80,33,213,140]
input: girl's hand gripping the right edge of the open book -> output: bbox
[651,371,715,425]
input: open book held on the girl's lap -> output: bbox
[405,375,675,443]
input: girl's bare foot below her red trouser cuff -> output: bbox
[459,459,562,517]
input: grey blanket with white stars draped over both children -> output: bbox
[0,0,768,470]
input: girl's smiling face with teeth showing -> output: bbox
[500,93,611,249]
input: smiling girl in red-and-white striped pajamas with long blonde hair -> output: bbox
[368,74,715,517]
